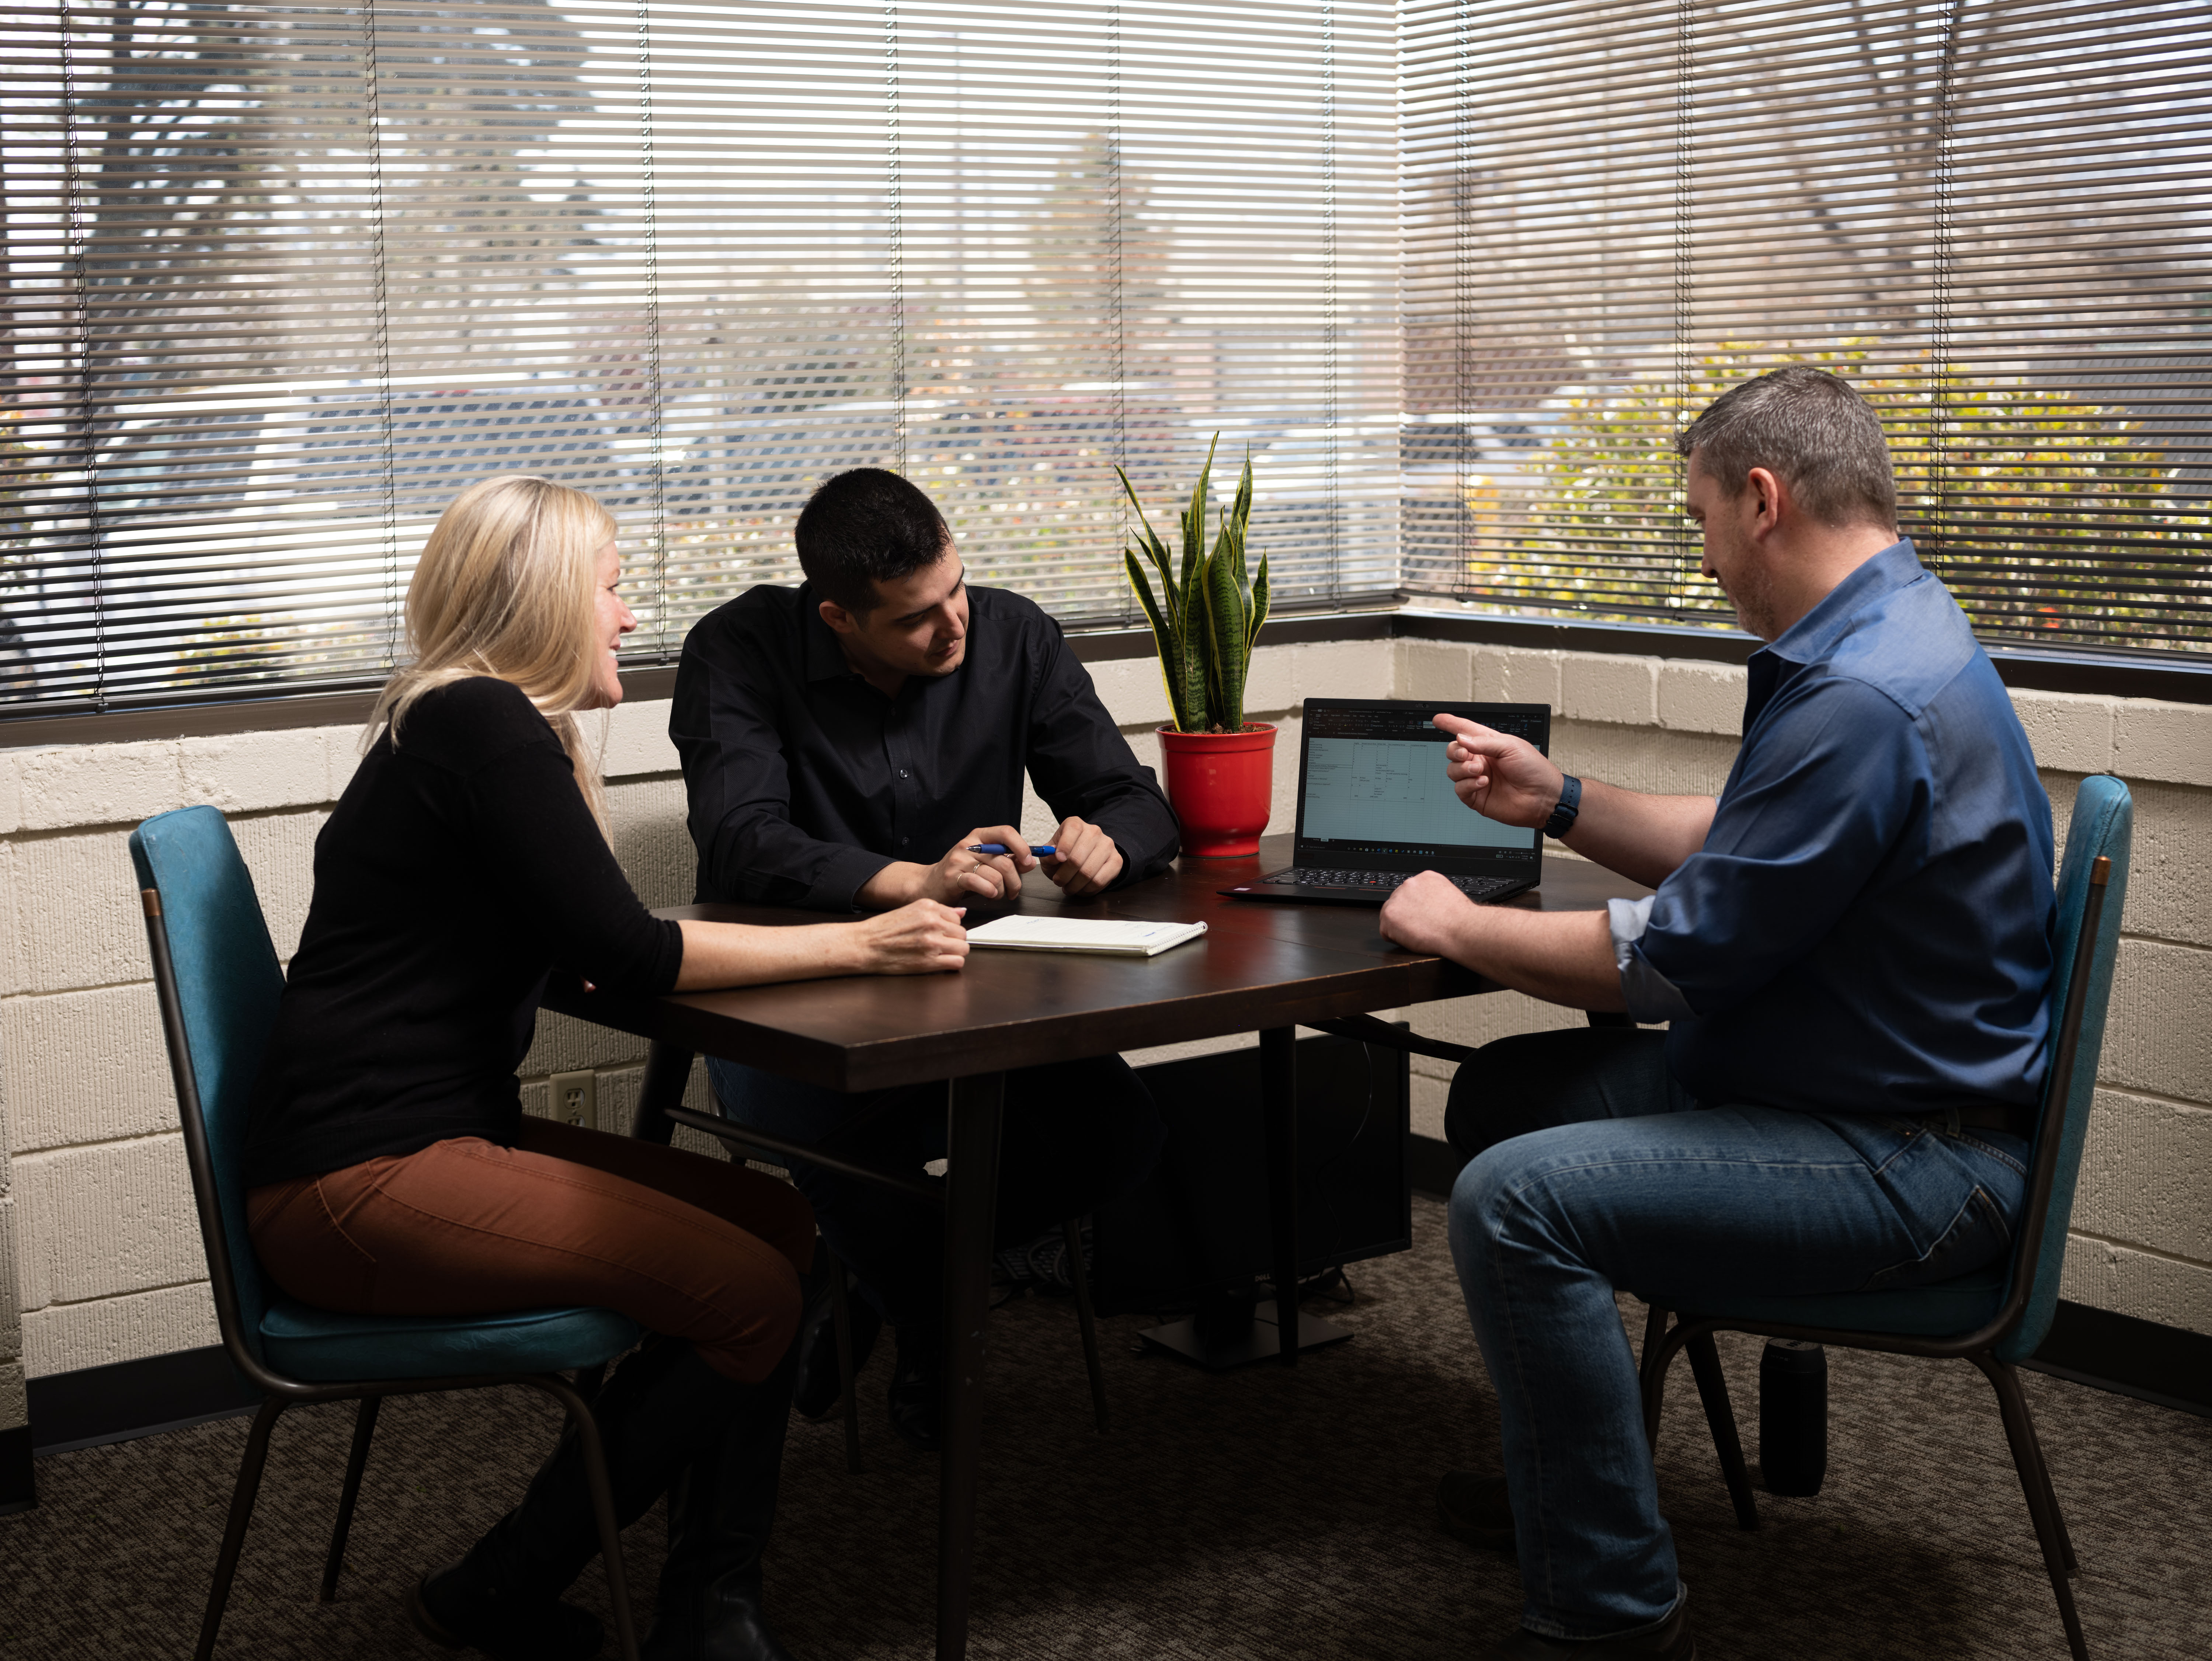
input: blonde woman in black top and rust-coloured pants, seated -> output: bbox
[246,476,967,1661]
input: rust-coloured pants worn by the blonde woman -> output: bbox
[246,1119,814,1385]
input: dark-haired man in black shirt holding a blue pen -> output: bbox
[668,467,1179,1449]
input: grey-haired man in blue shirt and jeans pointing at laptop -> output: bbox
[1382,367,2053,1661]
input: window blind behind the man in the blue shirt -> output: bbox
[1405,0,2212,650]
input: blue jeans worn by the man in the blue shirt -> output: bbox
[1447,1028,2028,1639]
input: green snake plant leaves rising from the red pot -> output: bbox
[1115,433,1267,732]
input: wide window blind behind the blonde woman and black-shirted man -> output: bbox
[0,0,1398,708]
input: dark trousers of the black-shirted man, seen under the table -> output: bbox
[706,1055,1168,1351]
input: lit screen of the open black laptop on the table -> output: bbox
[1298,699,1551,876]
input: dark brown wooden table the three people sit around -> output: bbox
[544,836,1646,1661]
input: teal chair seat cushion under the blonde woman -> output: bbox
[261,1298,639,1382]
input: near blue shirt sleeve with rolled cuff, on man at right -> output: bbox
[1613,677,1931,1020]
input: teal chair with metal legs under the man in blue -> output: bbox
[1639,774,2135,1661]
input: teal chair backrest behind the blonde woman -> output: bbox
[131,807,283,1382]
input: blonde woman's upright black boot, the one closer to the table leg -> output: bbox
[641,1349,799,1661]
